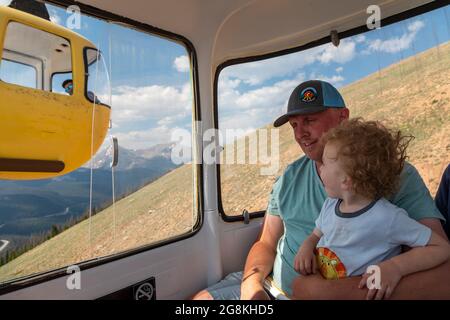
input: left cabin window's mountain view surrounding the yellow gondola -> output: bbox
[0,4,199,285]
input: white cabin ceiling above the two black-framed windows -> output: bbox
[76,0,431,66]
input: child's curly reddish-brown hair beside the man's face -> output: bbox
[322,118,414,199]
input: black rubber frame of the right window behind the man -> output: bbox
[213,1,449,222]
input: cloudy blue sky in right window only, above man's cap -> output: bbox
[219,7,450,131]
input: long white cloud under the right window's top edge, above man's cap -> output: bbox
[221,39,356,86]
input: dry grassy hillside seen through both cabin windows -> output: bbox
[0,43,450,282]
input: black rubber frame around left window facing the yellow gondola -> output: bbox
[0,0,204,296]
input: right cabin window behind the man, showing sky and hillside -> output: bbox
[217,6,450,216]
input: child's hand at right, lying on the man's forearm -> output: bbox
[358,260,402,300]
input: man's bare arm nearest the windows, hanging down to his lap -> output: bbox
[241,213,284,300]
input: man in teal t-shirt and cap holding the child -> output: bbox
[194,80,450,299]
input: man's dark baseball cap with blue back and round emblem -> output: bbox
[273,80,345,127]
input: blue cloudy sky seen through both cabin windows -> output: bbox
[0,0,450,149]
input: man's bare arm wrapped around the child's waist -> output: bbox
[292,218,450,300]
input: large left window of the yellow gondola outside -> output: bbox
[0,22,72,92]
